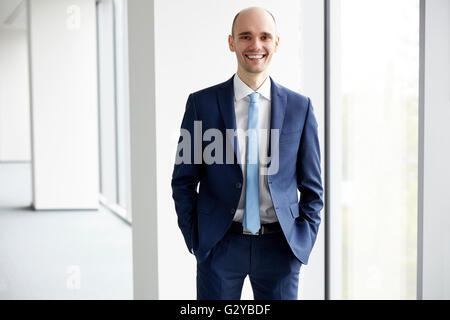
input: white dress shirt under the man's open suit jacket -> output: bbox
[233,74,278,224]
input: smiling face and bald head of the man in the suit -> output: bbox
[228,8,280,74]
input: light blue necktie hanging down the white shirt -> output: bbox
[243,92,261,234]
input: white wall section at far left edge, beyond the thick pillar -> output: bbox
[0,28,30,161]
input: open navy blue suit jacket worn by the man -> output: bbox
[172,77,323,264]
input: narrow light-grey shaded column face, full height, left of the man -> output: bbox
[127,0,160,299]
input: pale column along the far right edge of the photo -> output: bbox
[417,0,450,299]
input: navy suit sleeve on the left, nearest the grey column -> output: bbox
[171,94,201,253]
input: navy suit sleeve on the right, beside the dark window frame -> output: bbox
[297,98,323,238]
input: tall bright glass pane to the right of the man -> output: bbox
[340,0,419,299]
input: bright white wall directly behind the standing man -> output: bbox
[155,0,323,299]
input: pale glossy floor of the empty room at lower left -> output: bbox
[0,163,133,299]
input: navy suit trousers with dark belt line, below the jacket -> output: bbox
[197,231,301,300]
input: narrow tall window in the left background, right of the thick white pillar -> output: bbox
[97,0,131,221]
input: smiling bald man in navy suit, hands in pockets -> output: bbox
[172,7,323,299]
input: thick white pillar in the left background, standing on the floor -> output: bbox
[28,0,98,209]
